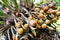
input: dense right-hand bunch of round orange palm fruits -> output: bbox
[34,2,60,28]
